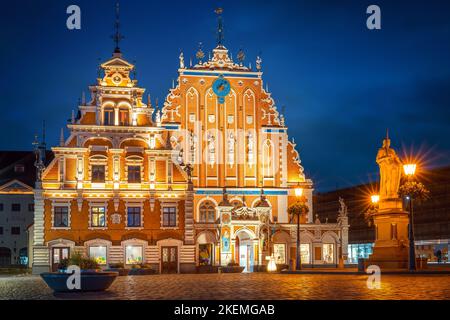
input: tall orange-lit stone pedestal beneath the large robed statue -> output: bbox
[366,200,409,270]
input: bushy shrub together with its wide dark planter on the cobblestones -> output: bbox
[41,253,119,292]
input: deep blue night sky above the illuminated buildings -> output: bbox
[0,0,450,191]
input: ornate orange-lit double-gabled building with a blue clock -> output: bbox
[34,8,346,272]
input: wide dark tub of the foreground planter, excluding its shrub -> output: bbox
[41,272,119,292]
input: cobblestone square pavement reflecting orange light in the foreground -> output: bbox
[0,273,450,300]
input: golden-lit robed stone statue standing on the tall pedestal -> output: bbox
[377,136,402,199]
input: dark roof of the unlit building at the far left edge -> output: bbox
[0,151,54,188]
